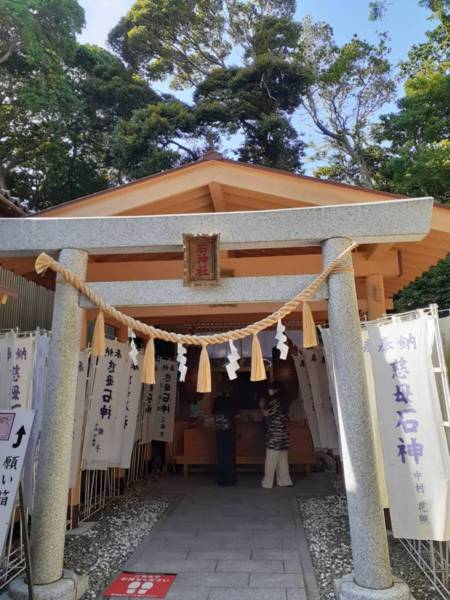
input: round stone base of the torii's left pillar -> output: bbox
[7,569,89,600]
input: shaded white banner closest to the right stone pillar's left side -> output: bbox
[301,348,339,452]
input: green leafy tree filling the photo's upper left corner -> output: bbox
[0,0,84,195]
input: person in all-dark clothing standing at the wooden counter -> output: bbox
[213,389,238,485]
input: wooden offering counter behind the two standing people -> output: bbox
[173,420,317,477]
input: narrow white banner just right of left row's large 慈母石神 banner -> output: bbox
[120,354,144,469]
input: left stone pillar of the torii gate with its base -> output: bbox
[8,249,88,600]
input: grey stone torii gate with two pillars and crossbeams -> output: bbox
[0,198,433,600]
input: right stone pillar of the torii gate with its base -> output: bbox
[322,238,411,600]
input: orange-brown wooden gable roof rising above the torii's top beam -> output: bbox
[35,152,401,217]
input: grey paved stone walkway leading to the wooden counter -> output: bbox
[124,474,331,600]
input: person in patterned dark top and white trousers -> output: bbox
[262,381,293,488]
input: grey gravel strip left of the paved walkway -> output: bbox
[64,483,169,600]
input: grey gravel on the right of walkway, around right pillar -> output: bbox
[298,496,441,600]
